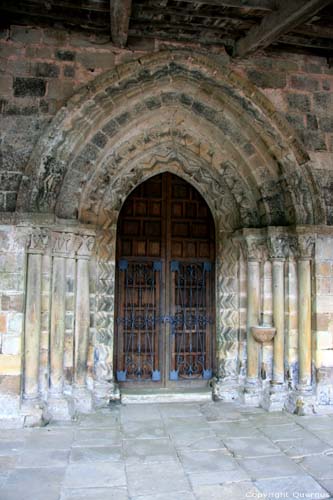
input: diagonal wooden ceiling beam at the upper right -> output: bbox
[232,0,332,57]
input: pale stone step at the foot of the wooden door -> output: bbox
[120,387,212,404]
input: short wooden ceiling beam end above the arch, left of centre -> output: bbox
[110,0,132,47]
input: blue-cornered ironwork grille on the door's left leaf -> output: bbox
[117,260,162,382]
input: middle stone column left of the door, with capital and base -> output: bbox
[48,232,75,419]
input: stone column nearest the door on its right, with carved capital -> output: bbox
[244,236,263,404]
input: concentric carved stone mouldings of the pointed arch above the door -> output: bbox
[18,51,325,226]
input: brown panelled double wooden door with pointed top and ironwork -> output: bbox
[115,173,215,386]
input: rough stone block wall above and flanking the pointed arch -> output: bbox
[0,26,333,224]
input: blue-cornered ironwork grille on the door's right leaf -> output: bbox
[168,261,213,380]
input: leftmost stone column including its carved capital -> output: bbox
[23,230,48,400]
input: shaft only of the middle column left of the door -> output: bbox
[50,256,66,394]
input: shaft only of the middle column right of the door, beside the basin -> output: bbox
[273,260,284,384]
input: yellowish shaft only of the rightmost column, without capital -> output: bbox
[298,259,311,386]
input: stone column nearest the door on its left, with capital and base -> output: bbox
[73,235,95,411]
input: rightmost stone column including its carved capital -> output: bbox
[297,236,314,390]
